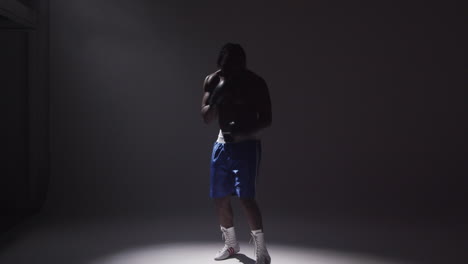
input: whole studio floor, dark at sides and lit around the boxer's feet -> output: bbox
[0,213,468,264]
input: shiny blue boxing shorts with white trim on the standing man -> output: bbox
[210,139,262,198]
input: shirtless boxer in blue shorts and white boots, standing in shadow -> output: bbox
[201,43,272,264]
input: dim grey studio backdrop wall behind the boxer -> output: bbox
[45,0,468,221]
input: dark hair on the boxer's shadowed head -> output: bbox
[216,43,247,70]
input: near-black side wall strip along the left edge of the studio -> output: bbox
[0,0,50,232]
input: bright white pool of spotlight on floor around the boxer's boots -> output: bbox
[90,242,402,264]
